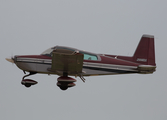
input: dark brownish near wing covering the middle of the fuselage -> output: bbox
[51,49,83,75]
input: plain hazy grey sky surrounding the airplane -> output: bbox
[0,0,167,120]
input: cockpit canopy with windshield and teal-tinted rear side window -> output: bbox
[41,46,99,60]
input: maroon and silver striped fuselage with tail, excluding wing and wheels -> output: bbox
[5,35,156,90]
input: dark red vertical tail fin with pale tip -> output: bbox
[133,35,156,66]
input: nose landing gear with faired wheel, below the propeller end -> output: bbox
[21,72,38,87]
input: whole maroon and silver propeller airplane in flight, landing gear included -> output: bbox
[6,34,156,90]
